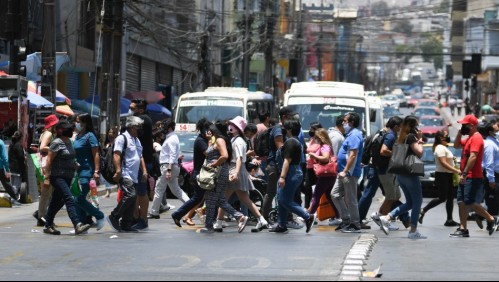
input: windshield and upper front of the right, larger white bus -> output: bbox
[288,97,367,131]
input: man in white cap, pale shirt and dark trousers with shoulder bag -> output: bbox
[107,116,147,232]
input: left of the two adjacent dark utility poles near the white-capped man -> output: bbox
[100,0,113,144]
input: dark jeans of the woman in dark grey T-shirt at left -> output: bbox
[45,176,81,228]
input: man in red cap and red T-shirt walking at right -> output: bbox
[450,115,498,238]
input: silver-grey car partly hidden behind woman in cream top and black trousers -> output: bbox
[420,142,462,198]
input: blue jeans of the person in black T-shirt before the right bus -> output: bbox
[277,165,310,227]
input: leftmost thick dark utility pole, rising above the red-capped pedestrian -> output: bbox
[41,0,57,104]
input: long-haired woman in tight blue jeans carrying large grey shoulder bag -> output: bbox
[380,116,427,239]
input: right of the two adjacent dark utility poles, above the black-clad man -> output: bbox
[108,0,124,128]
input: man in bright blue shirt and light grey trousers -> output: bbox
[331,112,364,233]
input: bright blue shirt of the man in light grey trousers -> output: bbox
[338,128,364,177]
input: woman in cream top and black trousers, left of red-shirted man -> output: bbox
[419,130,461,227]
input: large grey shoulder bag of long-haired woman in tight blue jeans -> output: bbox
[388,138,424,176]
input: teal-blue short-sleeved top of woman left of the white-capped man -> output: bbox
[73,132,99,178]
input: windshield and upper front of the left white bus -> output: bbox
[176,97,244,124]
